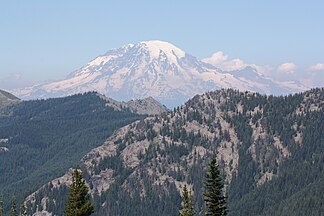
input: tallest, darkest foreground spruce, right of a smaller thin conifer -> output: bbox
[204,157,227,216]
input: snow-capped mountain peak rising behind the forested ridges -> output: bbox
[14,40,304,107]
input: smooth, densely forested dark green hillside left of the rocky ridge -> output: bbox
[0,93,143,212]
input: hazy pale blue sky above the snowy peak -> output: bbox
[0,0,324,88]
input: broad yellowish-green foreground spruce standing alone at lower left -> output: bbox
[65,169,94,216]
